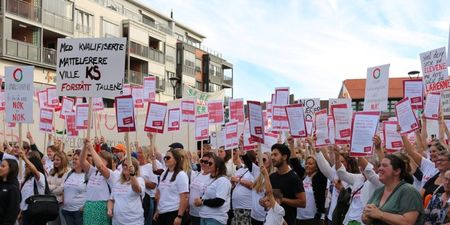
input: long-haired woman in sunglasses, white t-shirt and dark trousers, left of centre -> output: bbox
[154,149,189,225]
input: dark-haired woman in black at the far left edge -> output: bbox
[0,159,20,225]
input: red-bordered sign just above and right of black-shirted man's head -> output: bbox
[285,104,307,138]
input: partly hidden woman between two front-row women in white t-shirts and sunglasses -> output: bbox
[189,152,214,225]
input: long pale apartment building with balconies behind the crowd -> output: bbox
[0,0,233,106]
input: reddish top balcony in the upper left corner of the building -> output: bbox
[6,0,41,22]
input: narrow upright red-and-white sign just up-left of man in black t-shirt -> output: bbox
[247,101,264,143]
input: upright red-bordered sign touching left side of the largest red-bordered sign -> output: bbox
[331,104,352,144]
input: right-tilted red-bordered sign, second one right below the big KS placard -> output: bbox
[144,102,167,134]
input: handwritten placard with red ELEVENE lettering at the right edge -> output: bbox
[420,47,449,93]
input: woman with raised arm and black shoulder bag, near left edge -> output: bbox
[19,150,48,225]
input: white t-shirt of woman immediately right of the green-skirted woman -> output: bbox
[111,174,145,225]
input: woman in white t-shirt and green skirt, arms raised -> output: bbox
[80,139,113,225]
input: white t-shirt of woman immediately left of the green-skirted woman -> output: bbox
[63,172,86,211]
